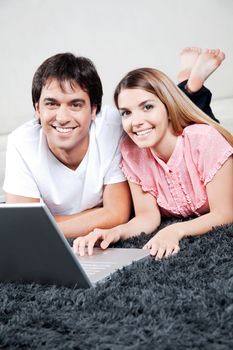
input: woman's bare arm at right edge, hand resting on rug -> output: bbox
[145,156,233,259]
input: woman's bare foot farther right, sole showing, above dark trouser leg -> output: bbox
[187,49,225,92]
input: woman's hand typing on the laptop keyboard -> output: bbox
[73,228,120,256]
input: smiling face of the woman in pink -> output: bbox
[118,89,172,151]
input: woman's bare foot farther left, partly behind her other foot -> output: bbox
[178,47,201,83]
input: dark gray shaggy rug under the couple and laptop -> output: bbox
[0,221,233,350]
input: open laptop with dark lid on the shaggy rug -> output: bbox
[0,203,149,288]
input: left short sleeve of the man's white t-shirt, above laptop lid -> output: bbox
[3,135,40,198]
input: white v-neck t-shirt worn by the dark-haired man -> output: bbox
[3,106,125,215]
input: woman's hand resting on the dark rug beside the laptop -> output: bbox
[143,224,182,259]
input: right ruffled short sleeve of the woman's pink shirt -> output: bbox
[196,125,233,186]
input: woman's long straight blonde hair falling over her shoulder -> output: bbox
[114,68,233,146]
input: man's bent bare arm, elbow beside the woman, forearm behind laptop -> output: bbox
[55,181,131,237]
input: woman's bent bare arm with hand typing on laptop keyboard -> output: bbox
[73,182,160,256]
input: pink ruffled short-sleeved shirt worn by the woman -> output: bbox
[121,124,233,217]
